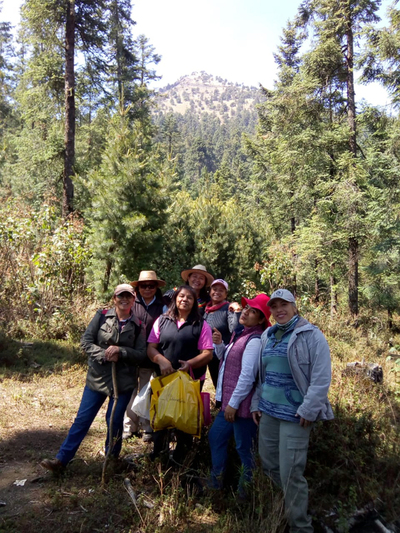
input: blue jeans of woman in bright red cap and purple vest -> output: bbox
[208,411,257,492]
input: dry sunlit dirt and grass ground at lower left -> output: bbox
[0,365,216,533]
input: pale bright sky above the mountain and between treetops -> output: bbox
[0,0,391,105]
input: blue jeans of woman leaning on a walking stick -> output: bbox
[56,386,132,466]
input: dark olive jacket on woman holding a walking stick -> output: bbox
[81,309,146,396]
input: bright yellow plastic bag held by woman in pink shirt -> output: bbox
[150,371,203,437]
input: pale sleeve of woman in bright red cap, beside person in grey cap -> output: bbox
[228,339,261,409]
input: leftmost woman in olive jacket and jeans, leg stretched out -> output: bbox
[41,283,146,472]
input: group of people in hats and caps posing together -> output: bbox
[41,265,333,533]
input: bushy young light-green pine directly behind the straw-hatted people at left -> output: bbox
[85,111,168,292]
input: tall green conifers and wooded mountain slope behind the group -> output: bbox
[0,0,400,322]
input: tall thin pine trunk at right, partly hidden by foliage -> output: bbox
[346,15,359,316]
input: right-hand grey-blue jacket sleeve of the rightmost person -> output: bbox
[297,329,331,425]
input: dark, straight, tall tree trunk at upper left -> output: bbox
[62,0,75,217]
